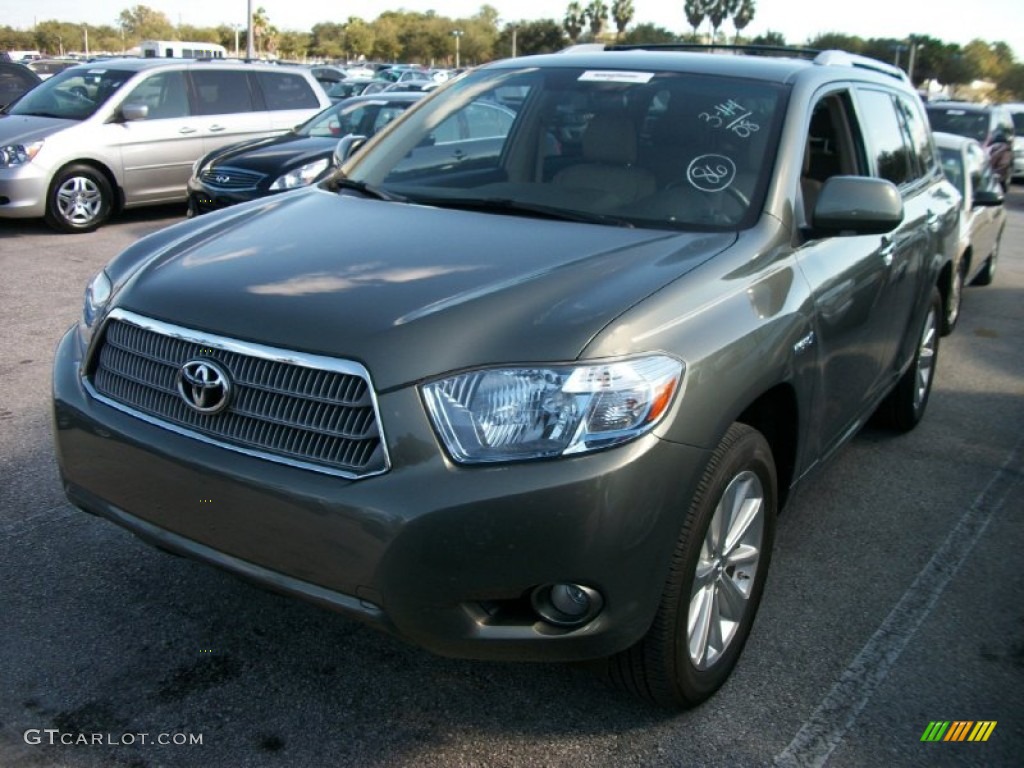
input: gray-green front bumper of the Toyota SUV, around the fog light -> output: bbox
[53,329,709,660]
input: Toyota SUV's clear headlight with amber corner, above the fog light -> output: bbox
[423,355,683,464]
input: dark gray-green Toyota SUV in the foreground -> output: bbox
[53,50,959,707]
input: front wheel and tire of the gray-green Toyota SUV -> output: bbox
[608,424,778,708]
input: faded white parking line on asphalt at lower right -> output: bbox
[774,438,1024,768]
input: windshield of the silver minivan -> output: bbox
[8,67,135,120]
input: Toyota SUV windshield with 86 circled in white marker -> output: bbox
[342,67,786,230]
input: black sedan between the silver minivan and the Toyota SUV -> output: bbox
[188,92,424,216]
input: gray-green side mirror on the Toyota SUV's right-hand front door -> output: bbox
[811,176,903,236]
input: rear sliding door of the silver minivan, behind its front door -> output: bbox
[189,63,271,152]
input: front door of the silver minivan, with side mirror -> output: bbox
[111,70,204,206]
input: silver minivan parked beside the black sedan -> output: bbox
[0,58,331,232]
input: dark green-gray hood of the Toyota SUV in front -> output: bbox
[112,186,735,390]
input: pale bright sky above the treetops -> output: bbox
[6,0,1024,61]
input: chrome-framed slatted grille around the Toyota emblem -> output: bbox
[88,310,388,478]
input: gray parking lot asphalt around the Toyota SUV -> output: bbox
[0,193,1024,768]
